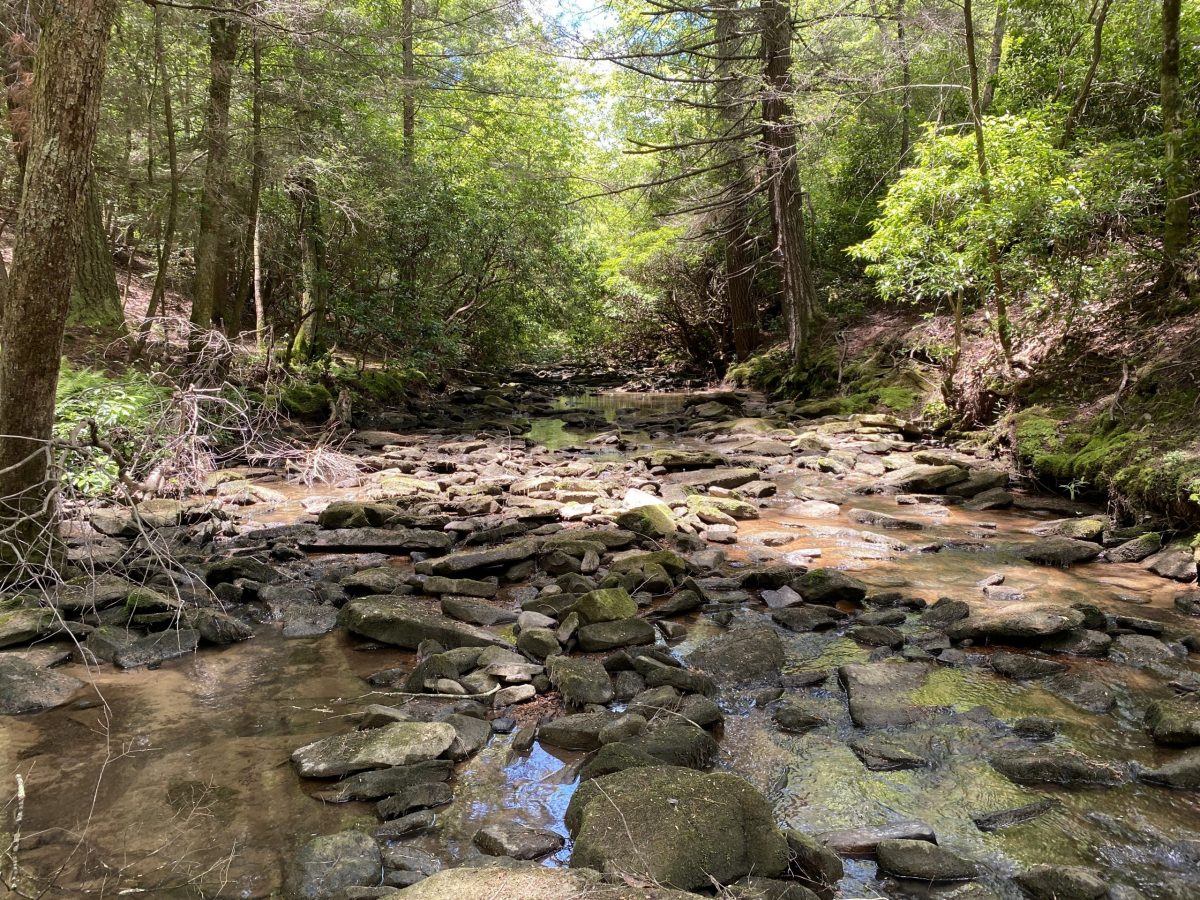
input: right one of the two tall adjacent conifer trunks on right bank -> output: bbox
[762,0,817,365]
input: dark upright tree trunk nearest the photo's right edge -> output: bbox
[1162,0,1190,283]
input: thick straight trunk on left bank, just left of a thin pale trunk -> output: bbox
[192,16,241,338]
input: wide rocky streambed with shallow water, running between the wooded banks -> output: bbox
[0,384,1200,900]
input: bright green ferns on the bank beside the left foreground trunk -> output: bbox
[54,362,170,497]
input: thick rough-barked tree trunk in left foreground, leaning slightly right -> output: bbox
[0,0,116,578]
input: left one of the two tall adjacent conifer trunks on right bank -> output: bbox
[715,0,761,360]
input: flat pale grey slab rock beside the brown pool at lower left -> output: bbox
[292,722,456,778]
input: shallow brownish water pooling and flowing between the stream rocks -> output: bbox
[0,394,1200,900]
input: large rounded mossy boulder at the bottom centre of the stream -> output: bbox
[566,766,787,889]
